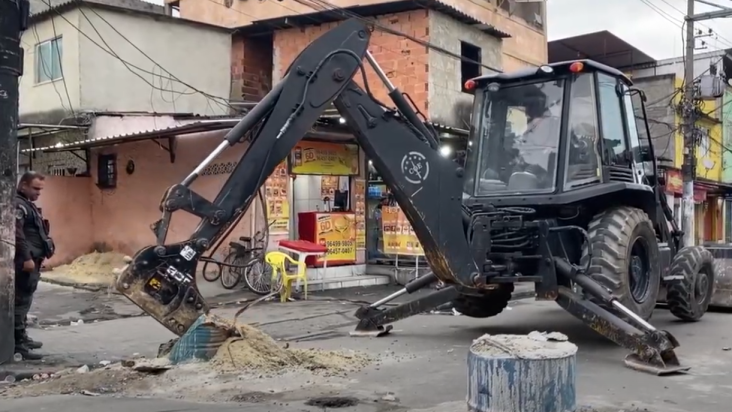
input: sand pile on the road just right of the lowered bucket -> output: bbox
[209,325,372,376]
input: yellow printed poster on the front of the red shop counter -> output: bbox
[316,213,356,263]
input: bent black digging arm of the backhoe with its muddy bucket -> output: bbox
[117,19,479,334]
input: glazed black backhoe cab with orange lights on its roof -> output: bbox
[464,60,652,206]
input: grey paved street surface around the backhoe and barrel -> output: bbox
[0,282,732,412]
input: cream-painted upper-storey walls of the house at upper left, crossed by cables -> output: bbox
[20,6,231,121]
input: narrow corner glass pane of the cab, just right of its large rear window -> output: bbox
[566,73,600,187]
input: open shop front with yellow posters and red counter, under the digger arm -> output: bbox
[265,139,378,287]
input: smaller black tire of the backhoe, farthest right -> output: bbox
[665,246,717,322]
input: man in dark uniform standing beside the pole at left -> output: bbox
[14,172,55,360]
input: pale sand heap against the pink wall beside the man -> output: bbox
[49,252,127,285]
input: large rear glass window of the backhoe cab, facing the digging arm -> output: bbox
[470,80,564,196]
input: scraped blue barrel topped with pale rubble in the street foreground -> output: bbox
[467,332,577,412]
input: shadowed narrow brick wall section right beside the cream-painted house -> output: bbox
[231,35,272,101]
